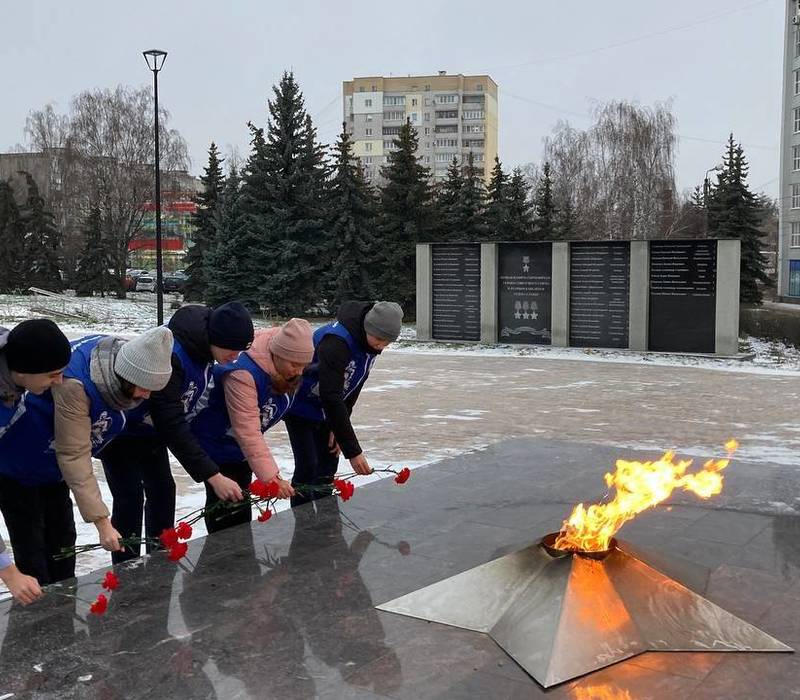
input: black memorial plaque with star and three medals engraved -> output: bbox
[497,243,553,345]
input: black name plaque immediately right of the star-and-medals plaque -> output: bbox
[569,241,631,348]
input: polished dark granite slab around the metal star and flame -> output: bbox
[0,439,800,700]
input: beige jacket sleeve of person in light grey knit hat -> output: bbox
[52,379,110,523]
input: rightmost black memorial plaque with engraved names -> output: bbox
[649,240,717,352]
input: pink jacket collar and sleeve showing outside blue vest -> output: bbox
[223,326,280,482]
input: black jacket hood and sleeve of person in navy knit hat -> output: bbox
[149,304,219,483]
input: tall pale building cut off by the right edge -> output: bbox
[778,0,800,300]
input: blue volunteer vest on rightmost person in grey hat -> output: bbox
[289,321,377,422]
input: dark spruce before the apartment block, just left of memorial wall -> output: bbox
[377,120,432,316]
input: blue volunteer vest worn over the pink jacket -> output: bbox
[190,352,293,464]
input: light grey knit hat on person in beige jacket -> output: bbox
[114,326,172,391]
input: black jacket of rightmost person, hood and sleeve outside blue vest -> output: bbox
[317,301,378,459]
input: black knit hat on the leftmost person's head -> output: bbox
[4,318,72,374]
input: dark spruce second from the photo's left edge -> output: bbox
[20,173,63,292]
